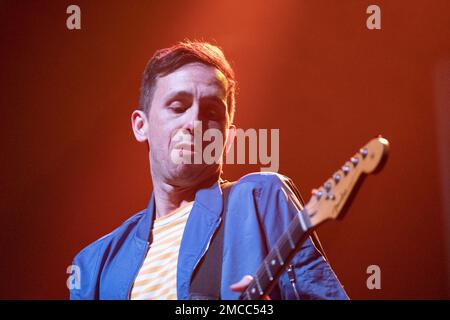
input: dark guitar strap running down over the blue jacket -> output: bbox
[189,181,234,300]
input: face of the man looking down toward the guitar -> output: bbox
[147,63,229,187]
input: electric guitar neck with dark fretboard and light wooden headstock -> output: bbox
[239,136,389,300]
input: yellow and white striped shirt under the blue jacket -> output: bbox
[131,201,194,300]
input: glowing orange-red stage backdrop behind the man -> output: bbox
[0,0,450,299]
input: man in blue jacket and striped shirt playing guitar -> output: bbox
[70,42,347,299]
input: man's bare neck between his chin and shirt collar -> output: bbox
[152,177,218,218]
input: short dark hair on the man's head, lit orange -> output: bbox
[139,41,236,122]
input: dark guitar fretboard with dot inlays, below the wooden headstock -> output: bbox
[239,211,311,300]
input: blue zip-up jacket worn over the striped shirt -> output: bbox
[70,173,347,300]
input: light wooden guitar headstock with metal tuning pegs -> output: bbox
[305,136,389,226]
